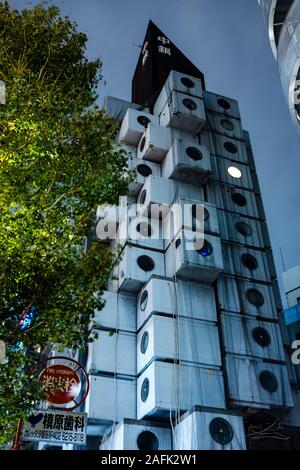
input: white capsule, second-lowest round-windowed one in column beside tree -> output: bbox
[117,216,164,251]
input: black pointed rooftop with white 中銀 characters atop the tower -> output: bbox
[132,21,205,110]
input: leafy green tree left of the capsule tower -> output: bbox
[0,2,128,443]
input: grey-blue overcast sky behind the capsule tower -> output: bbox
[10,0,300,302]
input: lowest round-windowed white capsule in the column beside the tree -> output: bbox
[114,245,165,293]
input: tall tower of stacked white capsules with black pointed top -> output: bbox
[85,22,300,450]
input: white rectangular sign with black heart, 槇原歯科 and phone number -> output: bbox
[21,410,87,445]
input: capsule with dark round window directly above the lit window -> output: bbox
[209,134,248,164]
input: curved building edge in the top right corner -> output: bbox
[258,0,300,131]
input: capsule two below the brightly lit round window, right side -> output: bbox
[218,209,265,248]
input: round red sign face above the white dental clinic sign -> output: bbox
[39,364,81,405]
